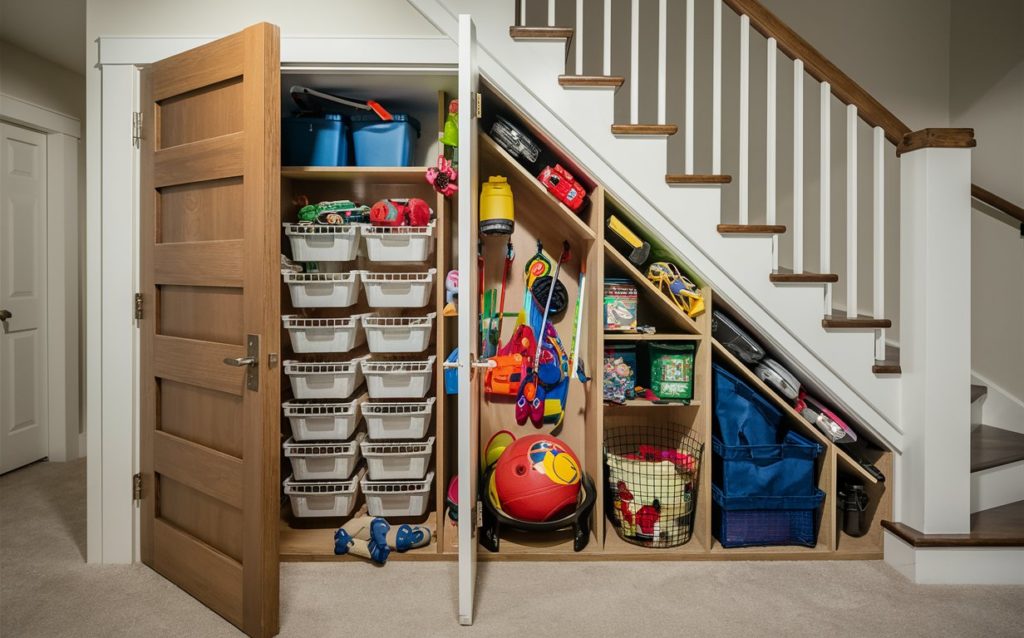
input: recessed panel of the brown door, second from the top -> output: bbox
[157,177,243,244]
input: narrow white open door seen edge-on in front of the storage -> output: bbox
[457,15,482,625]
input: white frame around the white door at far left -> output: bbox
[0,93,83,462]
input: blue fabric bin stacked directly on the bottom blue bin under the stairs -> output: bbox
[712,432,823,498]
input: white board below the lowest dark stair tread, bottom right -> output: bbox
[884,531,1024,585]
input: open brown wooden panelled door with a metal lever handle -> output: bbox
[138,24,281,636]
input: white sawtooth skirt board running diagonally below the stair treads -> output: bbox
[410,0,903,451]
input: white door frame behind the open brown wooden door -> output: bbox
[86,36,458,563]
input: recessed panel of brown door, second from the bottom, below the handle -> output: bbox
[157,379,243,459]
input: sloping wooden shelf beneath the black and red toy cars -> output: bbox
[479,132,597,246]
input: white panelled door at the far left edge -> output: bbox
[0,123,47,473]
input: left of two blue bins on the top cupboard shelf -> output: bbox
[281,113,349,166]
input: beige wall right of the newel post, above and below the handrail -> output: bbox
[949,0,1024,398]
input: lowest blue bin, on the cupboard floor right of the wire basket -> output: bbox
[711,485,825,548]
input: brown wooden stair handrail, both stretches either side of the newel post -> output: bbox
[722,0,1024,228]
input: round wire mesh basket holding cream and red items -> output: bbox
[604,424,703,548]
